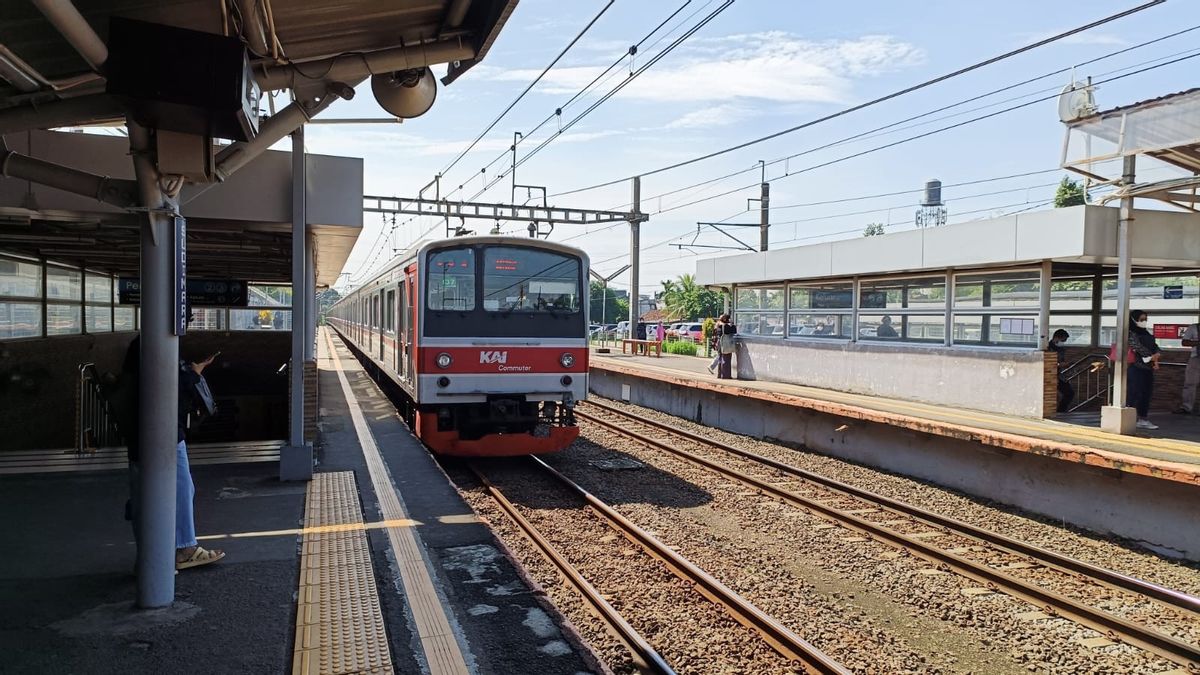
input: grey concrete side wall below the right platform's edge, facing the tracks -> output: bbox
[590,370,1200,560]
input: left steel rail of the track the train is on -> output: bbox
[467,462,674,675]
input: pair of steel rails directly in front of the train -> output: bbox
[468,456,850,675]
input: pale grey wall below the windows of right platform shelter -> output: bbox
[736,336,1045,417]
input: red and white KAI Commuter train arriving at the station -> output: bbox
[326,237,588,456]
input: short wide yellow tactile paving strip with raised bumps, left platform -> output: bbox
[292,471,392,675]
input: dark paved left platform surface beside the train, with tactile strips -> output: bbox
[0,326,596,675]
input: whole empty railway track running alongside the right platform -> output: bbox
[576,400,1200,669]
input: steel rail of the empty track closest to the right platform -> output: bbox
[588,400,1200,617]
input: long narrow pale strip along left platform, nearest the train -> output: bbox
[322,329,470,675]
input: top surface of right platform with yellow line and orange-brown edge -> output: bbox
[592,352,1200,485]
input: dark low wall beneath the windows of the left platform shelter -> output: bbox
[0,331,290,452]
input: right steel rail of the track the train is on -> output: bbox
[520,456,851,675]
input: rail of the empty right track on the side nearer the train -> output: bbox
[576,406,1200,668]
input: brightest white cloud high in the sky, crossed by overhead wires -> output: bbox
[484,31,924,103]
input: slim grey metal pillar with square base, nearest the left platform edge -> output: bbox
[280,126,312,480]
